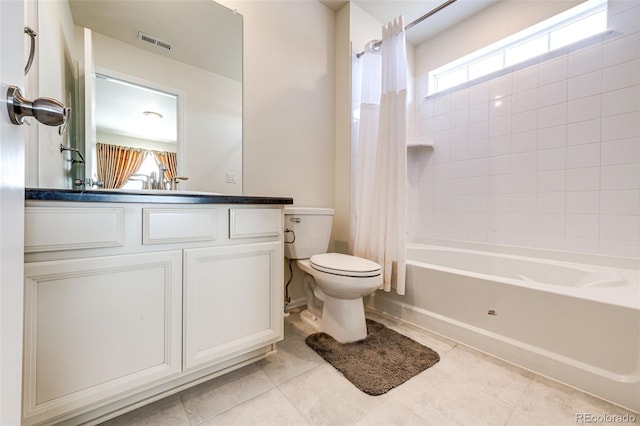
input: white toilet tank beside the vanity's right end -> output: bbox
[284,207,333,259]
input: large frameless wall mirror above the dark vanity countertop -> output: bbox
[27,0,242,195]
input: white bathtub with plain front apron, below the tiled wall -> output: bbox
[369,245,640,411]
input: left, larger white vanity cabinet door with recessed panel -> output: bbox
[24,250,182,424]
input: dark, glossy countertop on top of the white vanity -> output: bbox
[25,188,293,204]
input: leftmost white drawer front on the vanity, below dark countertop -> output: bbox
[24,207,124,253]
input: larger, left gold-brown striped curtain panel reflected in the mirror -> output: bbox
[96,143,145,188]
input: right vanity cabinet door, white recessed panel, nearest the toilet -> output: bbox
[183,241,283,369]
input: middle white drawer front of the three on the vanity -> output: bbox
[142,208,218,244]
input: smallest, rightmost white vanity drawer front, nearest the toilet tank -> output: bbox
[229,208,283,239]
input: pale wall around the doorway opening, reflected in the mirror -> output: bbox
[93,32,242,195]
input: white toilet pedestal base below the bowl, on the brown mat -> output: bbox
[321,295,367,343]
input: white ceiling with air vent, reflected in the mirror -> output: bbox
[69,0,242,81]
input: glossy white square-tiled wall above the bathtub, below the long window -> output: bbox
[409,0,640,257]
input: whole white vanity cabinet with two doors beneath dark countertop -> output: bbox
[23,201,283,425]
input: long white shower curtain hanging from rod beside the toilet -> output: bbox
[353,17,407,294]
